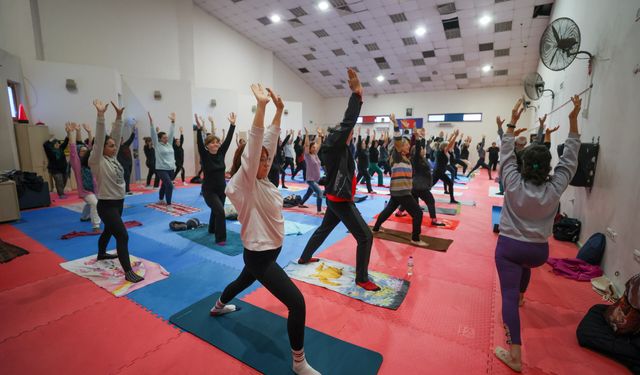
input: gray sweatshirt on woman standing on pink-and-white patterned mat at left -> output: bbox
[89,116,124,200]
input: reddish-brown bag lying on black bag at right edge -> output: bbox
[604,274,640,335]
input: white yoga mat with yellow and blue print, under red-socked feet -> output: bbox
[284,259,409,310]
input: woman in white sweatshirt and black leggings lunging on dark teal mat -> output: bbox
[211,84,319,375]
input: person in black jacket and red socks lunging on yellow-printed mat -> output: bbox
[298,69,380,291]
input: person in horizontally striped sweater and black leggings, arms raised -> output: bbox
[373,113,428,246]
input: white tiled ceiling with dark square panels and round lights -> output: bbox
[194,0,554,97]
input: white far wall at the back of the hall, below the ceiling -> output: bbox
[323,86,533,163]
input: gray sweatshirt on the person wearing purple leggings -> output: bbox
[500,133,580,243]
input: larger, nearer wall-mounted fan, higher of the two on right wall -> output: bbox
[540,17,592,71]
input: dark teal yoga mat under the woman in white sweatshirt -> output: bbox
[169,293,382,374]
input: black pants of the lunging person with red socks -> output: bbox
[300,199,373,283]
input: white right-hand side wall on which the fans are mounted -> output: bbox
[538,0,640,290]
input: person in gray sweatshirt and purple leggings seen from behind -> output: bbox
[495,95,582,372]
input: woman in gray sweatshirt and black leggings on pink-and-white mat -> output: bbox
[89,100,144,283]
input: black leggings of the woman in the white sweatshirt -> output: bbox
[220,247,306,350]
